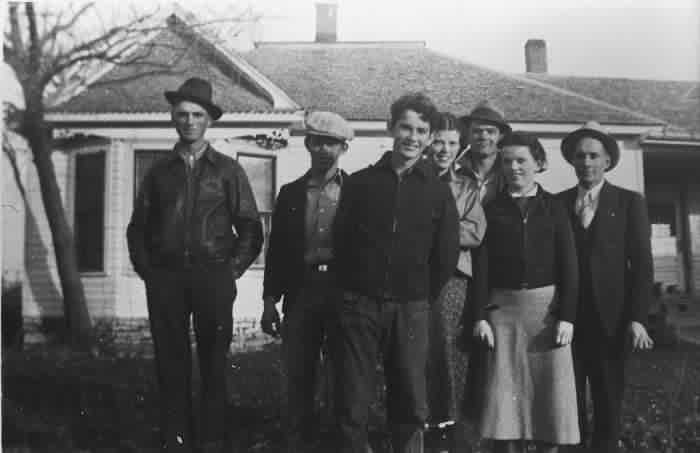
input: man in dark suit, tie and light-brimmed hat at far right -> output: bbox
[559,121,653,453]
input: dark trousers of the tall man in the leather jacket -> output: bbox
[146,263,236,452]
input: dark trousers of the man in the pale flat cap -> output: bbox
[282,271,339,451]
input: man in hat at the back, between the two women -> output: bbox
[455,100,511,205]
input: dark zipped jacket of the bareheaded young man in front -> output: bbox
[333,152,459,302]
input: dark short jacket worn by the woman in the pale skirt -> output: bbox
[473,187,578,322]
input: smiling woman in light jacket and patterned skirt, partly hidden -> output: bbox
[427,113,486,451]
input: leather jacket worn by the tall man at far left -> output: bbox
[127,145,263,279]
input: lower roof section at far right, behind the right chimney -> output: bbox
[527,74,700,132]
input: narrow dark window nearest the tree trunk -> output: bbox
[74,151,105,272]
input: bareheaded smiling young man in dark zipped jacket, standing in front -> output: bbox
[331,94,459,453]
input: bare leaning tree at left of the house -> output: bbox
[4,2,257,348]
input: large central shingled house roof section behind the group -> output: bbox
[243,42,664,125]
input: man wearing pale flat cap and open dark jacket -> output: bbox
[261,112,353,452]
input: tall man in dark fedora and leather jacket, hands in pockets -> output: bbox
[127,78,263,452]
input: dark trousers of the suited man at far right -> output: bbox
[572,313,627,453]
